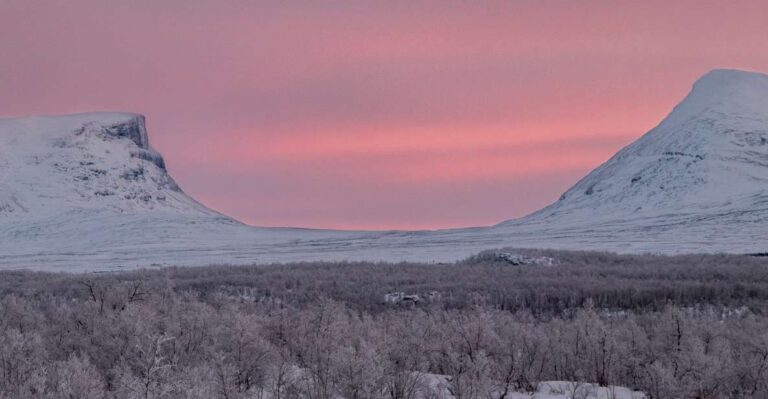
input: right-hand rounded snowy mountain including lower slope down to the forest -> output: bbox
[486,70,768,253]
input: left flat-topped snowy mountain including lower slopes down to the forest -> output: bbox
[0,113,366,270]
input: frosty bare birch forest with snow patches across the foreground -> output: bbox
[0,250,768,399]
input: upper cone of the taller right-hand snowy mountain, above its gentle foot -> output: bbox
[500,70,768,223]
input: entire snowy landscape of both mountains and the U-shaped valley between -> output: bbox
[0,70,768,270]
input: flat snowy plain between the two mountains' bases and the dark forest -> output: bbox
[6,208,768,271]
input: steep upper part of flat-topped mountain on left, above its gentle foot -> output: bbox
[0,113,215,218]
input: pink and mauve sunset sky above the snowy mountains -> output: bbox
[0,0,768,229]
